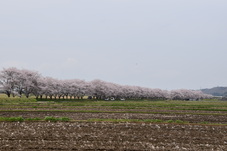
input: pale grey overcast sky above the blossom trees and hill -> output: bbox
[0,0,227,90]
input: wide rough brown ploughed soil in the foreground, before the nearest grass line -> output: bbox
[0,122,227,151]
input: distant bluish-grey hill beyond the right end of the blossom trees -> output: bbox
[201,87,227,97]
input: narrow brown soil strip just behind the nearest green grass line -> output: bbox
[0,111,227,124]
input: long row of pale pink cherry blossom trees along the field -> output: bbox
[0,67,211,100]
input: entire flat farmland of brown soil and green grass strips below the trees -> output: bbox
[0,96,227,150]
